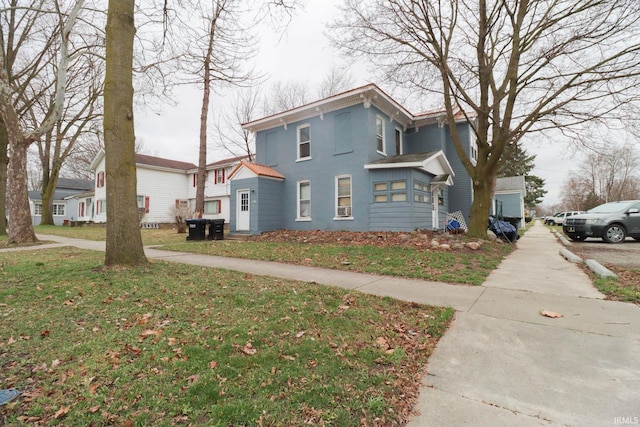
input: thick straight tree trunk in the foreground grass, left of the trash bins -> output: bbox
[104,0,147,266]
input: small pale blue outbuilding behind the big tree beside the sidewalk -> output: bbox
[491,176,527,228]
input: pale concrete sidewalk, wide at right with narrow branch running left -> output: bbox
[30,224,640,427]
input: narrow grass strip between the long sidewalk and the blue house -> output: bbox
[163,240,515,285]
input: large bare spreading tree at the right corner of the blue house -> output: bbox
[333,0,640,237]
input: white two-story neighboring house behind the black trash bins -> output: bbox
[91,150,248,224]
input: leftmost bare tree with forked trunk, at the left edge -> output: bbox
[0,0,84,243]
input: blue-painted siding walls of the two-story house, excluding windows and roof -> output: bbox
[248,99,472,232]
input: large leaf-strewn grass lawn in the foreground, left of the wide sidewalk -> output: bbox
[0,248,453,426]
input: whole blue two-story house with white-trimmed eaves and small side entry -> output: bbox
[230,84,477,234]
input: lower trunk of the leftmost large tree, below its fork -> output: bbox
[7,141,38,243]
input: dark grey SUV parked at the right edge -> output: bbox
[562,200,640,243]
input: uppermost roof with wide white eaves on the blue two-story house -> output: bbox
[242,83,466,132]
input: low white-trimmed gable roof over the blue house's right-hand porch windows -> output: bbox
[364,150,455,185]
